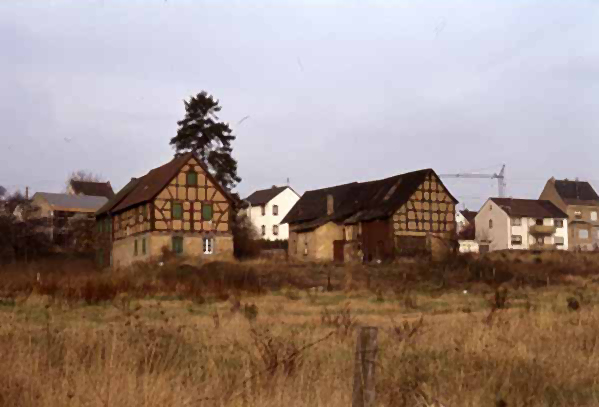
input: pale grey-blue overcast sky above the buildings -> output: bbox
[0,0,599,209]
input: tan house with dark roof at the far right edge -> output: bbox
[540,177,599,250]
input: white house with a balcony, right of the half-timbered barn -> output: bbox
[475,198,568,253]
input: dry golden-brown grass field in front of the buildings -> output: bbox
[0,254,599,407]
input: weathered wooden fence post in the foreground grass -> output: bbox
[352,326,378,407]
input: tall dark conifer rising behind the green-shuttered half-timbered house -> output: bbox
[170,91,241,190]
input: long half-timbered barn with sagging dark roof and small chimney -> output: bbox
[281,169,457,262]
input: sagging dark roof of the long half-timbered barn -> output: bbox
[281,168,457,228]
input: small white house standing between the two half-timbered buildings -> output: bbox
[243,185,300,240]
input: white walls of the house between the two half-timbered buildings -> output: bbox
[246,188,299,240]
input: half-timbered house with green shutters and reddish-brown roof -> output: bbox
[96,153,235,267]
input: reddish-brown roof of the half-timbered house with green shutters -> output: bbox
[110,153,237,212]
